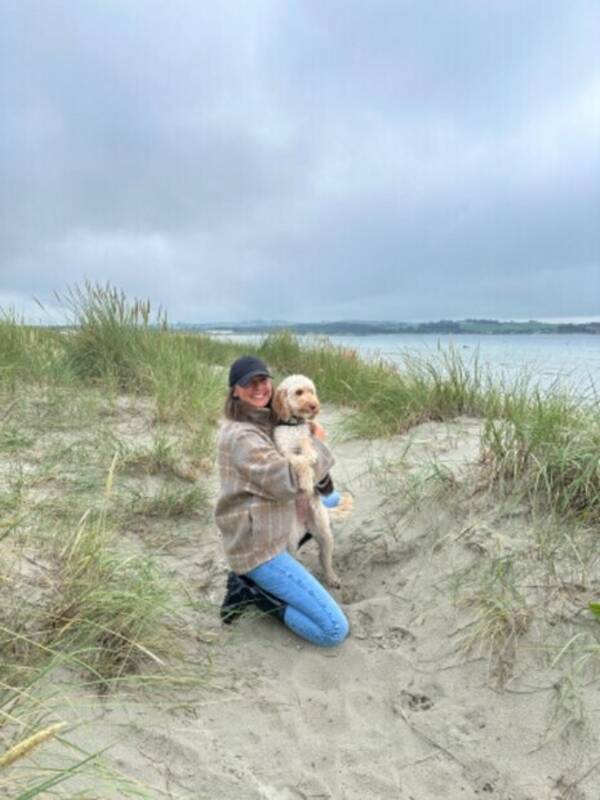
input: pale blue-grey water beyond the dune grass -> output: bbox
[207,333,600,399]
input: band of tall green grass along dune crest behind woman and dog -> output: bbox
[0,283,600,568]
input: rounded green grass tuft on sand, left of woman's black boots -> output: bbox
[46,515,176,680]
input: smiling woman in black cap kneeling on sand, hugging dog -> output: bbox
[215,356,348,647]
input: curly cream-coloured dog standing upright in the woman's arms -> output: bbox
[273,375,341,589]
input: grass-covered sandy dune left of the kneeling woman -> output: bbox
[0,291,222,798]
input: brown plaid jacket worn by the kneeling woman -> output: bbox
[215,420,334,574]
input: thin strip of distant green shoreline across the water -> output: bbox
[173,319,600,336]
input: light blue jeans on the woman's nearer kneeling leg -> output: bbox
[246,551,349,647]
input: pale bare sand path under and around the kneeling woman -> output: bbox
[9,408,600,800]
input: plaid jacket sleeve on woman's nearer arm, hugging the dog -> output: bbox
[231,424,298,500]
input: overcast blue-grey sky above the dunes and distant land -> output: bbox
[0,0,600,323]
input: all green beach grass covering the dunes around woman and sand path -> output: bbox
[0,284,600,797]
